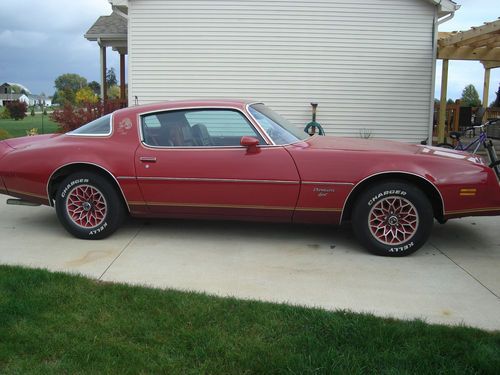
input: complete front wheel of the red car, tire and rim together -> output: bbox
[352,180,434,257]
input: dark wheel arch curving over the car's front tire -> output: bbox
[340,171,444,223]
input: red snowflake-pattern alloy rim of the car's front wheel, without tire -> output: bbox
[368,197,419,246]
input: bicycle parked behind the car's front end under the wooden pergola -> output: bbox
[437,119,500,179]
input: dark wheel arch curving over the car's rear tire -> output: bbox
[47,162,130,213]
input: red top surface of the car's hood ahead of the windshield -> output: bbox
[305,136,422,154]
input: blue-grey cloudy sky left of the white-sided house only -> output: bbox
[0,0,115,95]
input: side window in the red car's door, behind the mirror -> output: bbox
[141,109,264,147]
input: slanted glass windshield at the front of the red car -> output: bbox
[249,103,307,145]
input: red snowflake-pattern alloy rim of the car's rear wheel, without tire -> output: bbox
[66,185,107,228]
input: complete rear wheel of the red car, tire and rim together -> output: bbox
[56,172,126,240]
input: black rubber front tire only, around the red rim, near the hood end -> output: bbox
[352,182,434,257]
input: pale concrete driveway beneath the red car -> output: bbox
[0,195,500,330]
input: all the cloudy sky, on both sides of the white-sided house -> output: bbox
[0,0,500,102]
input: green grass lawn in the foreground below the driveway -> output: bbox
[0,266,500,374]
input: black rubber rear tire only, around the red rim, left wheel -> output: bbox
[55,173,124,240]
